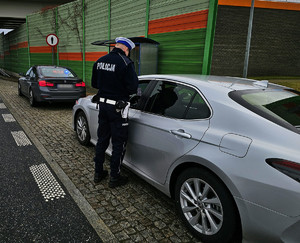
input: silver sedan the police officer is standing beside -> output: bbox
[73,75,300,242]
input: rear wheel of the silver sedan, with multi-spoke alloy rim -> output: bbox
[175,168,239,243]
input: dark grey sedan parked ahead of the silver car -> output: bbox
[18,66,86,106]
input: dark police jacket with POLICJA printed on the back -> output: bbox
[92,48,138,101]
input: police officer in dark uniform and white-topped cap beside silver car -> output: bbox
[92,37,138,188]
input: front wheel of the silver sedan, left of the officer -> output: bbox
[75,111,91,146]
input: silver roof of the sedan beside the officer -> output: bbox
[139,74,286,91]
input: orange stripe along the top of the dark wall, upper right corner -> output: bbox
[219,0,300,11]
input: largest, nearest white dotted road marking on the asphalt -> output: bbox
[29,164,66,202]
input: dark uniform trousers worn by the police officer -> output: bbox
[94,102,128,178]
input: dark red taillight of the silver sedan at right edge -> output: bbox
[266,159,300,182]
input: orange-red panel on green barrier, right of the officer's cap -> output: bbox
[148,10,208,34]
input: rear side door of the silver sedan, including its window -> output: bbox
[127,81,211,184]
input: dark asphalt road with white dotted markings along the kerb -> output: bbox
[0,96,101,243]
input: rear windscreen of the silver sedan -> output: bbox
[230,89,300,130]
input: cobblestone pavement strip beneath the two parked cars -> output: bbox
[0,79,197,242]
